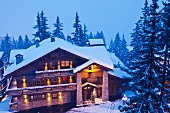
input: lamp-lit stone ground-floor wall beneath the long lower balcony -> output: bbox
[17,92,71,111]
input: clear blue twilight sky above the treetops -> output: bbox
[0,0,163,45]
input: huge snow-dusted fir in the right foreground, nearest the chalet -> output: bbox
[120,0,170,113]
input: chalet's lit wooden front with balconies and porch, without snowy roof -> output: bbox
[6,44,126,111]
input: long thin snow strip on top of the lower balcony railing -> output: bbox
[7,83,77,91]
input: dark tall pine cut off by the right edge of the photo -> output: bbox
[157,1,170,112]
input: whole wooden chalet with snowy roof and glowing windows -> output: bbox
[4,38,127,111]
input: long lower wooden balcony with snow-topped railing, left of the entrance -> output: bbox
[6,83,77,96]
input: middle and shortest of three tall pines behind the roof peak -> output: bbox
[53,16,66,40]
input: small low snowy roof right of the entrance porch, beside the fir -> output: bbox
[108,68,130,78]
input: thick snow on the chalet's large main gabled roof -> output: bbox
[4,38,113,75]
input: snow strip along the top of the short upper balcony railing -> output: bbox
[35,68,74,73]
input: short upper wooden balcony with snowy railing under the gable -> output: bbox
[35,68,73,78]
